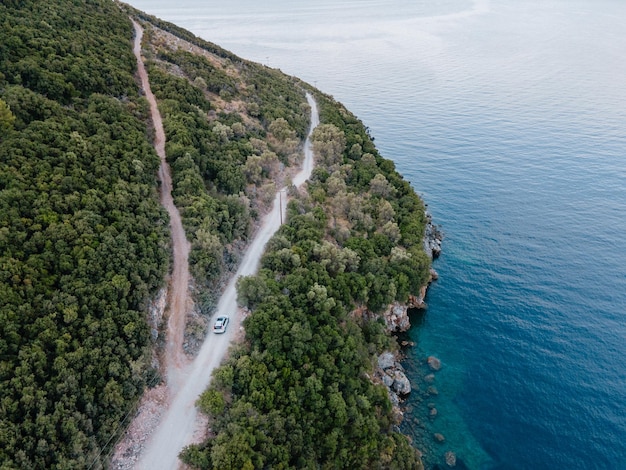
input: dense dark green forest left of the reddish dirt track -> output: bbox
[0,0,167,469]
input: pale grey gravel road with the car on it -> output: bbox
[136,74,319,470]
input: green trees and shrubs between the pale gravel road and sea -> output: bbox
[178,90,430,469]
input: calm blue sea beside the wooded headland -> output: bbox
[130,0,626,469]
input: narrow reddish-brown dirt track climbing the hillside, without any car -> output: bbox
[131,19,192,393]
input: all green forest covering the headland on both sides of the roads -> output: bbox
[0,0,429,469]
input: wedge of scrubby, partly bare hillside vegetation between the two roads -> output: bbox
[129,12,308,316]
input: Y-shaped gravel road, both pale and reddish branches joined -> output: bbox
[133,21,319,470]
